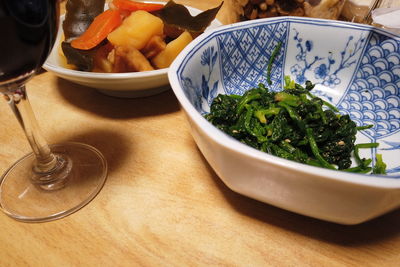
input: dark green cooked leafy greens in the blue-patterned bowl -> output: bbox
[205,76,386,174]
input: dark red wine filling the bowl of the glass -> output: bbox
[0,0,58,82]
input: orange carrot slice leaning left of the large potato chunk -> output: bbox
[71,9,122,50]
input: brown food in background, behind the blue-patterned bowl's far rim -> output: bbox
[221,0,345,23]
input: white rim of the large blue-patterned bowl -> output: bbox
[168,17,400,189]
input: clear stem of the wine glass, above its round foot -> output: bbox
[5,85,70,190]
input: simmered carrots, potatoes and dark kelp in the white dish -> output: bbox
[61,0,222,73]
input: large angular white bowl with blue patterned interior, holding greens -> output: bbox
[168,17,400,224]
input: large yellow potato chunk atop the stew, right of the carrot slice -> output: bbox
[107,10,164,50]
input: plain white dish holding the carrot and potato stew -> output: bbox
[43,1,222,98]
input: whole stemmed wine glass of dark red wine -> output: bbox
[0,0,107,222]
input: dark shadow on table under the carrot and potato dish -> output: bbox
[57,78,179,119]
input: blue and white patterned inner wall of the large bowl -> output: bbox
[178,18,400,178]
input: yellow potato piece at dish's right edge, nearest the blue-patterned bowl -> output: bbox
[151,32,193,69]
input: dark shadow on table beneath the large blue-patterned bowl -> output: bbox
[199,157,400,247]
